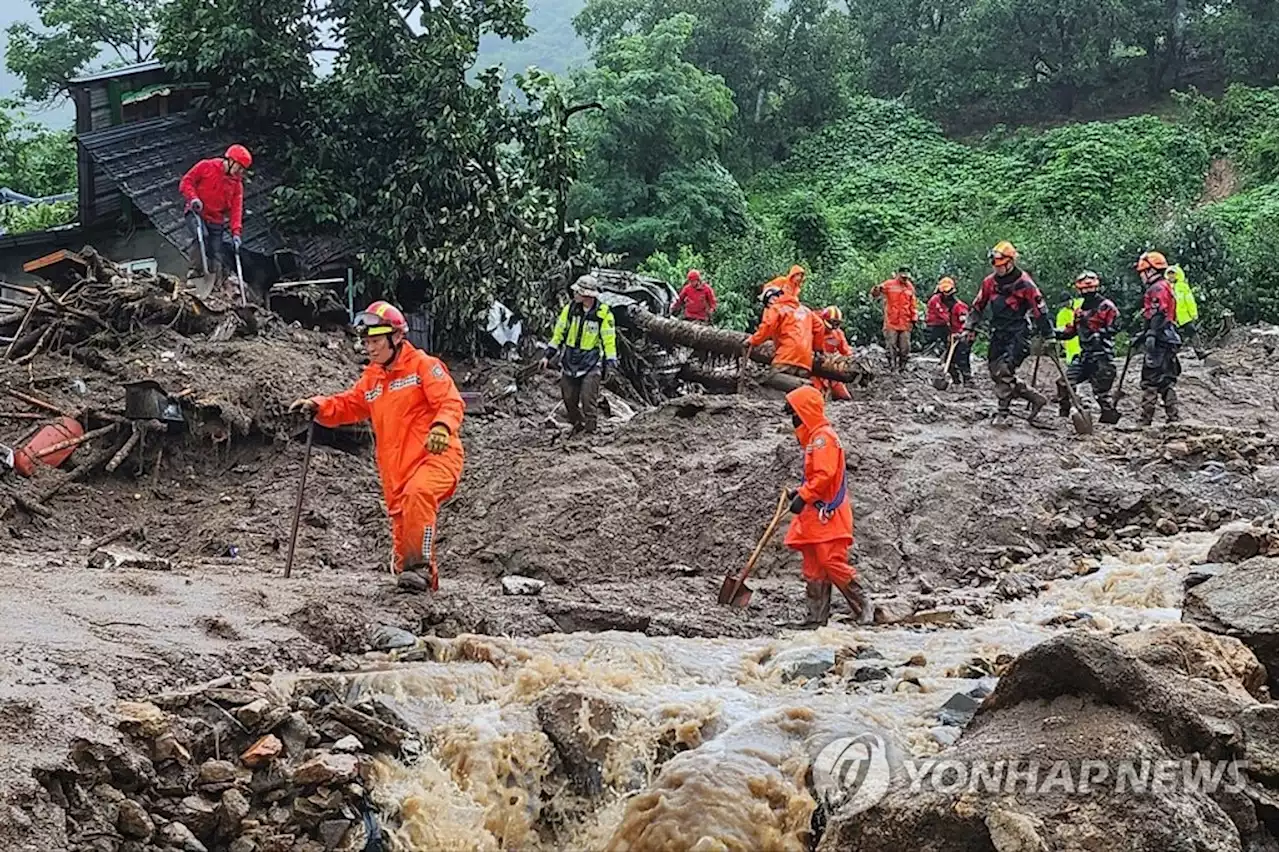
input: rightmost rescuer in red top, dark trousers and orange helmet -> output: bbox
[1130,252,1183,426]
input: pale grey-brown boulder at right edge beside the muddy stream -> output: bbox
[1183,556,1280,695]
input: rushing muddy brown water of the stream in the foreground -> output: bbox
[277,533,1220,852]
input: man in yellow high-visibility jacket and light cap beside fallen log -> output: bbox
[541,275,618,435]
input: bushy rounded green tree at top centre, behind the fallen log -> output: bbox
[571,14,746,260]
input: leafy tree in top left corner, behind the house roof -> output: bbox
[5,0,164,101]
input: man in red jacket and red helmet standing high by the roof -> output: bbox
[178,145,253,285]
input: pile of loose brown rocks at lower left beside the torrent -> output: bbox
[36,675,421,852]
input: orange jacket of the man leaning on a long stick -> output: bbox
[316,340,465,512]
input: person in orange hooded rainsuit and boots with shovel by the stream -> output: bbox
[783,385,872,627]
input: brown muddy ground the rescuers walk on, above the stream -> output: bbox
[0,301,1280,849]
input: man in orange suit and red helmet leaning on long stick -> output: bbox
[291,302,465,592]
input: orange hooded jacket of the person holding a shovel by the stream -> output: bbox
[785,385,854,548]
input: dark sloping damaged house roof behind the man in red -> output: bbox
[78,113,355,271]
